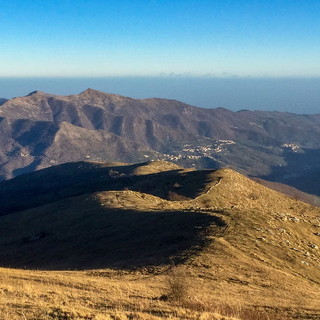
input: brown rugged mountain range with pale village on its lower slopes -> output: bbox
[0,89,320,194]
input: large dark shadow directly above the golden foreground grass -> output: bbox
[0,200,225,270]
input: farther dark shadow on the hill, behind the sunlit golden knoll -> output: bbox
[0,162,218,216]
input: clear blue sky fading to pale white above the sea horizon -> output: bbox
[0,0,320,77]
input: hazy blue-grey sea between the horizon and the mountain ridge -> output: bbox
[0,76,320,114]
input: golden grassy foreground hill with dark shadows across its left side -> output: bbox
[0,162,320,320]
